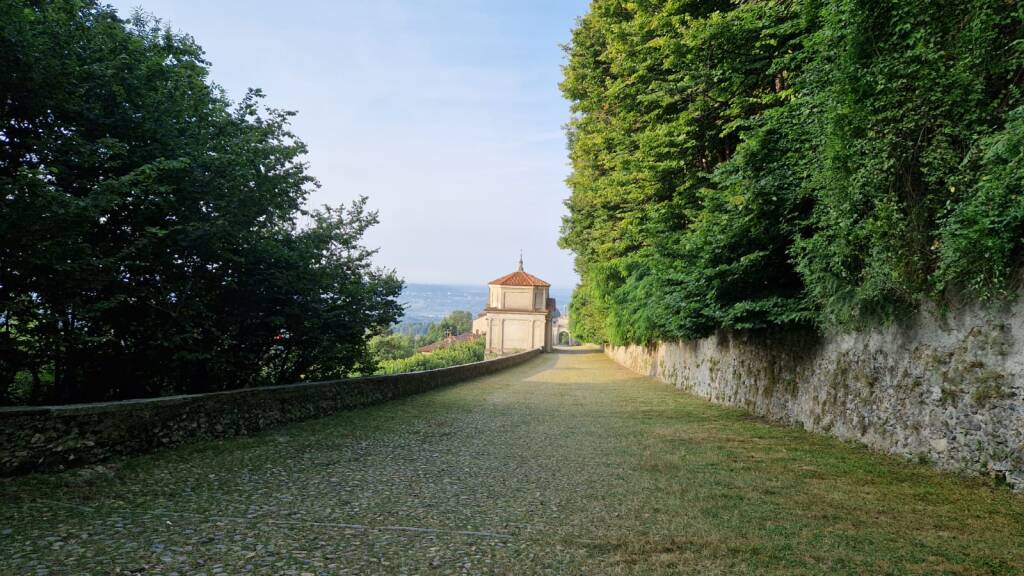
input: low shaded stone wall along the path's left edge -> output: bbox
[0,351,540,476]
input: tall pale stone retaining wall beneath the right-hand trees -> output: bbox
[605,302,1024,490]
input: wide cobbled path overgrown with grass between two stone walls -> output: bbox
[0,354,1024,574]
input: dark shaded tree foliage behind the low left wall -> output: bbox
[0,0,401,404]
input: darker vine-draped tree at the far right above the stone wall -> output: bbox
[793,0,1024,325]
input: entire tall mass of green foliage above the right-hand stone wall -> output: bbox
[561,0,1024,343]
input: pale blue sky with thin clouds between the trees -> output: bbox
[111,0,587,288]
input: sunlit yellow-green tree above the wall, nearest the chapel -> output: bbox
[561,0,801,342]
